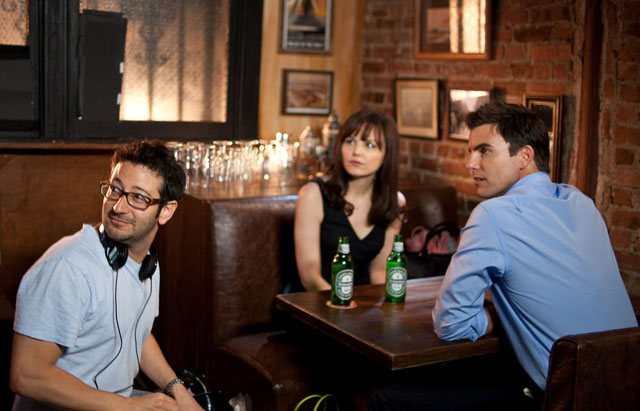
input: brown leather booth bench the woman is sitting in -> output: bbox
[154,185,457,410]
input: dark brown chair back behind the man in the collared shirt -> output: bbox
[544,327,640,411]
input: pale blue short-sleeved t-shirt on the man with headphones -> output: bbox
[14,225,160,396]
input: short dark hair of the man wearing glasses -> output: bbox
[111,141,186,204]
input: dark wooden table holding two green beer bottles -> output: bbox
[276,277,499,370]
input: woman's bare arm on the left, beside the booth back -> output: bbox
[293,183,331,290]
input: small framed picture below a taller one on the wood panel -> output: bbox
[282,70,333,116]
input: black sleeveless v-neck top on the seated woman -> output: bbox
[312,179,387,285]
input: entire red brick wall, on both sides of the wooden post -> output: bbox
[362,0,640,294]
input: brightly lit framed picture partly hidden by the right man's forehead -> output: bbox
[447,86,491,140]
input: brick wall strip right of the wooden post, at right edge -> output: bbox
[595,0,640,295]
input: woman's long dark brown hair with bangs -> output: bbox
[321,109,402,225]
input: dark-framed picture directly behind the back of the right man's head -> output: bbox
[522,93,562,183]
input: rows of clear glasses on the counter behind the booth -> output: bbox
[167,138,299,188]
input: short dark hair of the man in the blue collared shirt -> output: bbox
[467,101,549,173]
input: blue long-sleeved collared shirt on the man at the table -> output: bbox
[433,172,638,389]
